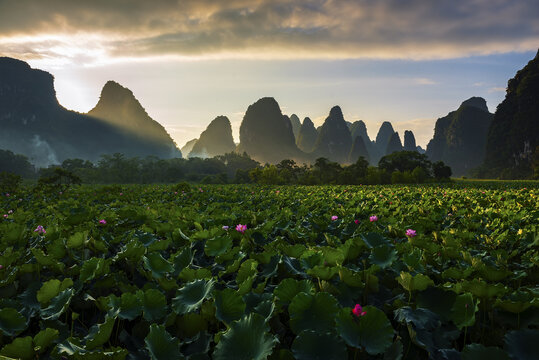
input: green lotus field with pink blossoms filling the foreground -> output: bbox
[0,182,539,360]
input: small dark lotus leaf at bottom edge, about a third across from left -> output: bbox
[144,324,184,360]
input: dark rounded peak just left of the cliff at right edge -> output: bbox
[426,98,492,176]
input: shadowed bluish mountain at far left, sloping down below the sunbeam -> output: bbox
[0,58,181,166]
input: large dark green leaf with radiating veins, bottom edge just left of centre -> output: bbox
[213,314,278,360]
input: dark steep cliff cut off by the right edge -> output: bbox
[484,52,539,178]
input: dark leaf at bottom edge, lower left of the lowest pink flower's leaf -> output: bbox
[292,330,348,360]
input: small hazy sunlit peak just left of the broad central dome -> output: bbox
[189,116,236,158]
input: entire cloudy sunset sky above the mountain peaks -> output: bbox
[0,0,539,146]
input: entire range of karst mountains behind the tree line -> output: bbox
[0,53,539,177]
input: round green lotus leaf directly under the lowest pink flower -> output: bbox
[336,306,394,355]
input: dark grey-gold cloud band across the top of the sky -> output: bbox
[0,0,539,58]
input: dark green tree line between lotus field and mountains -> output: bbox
[0,150,451,185]
